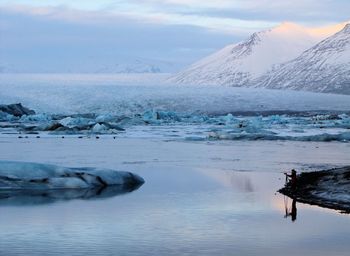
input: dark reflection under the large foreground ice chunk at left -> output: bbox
[0,184,142,206]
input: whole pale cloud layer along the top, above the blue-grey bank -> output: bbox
[0,0,350,35]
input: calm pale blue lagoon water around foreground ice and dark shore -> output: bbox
[0,136,350,256]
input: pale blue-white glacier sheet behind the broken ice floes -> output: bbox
[0,80,350,114]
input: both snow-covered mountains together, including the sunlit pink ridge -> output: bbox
[169,23,350,94]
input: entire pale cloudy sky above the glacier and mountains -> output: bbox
[0,0,350,70]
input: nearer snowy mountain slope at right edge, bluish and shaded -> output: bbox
[255,23,350,94]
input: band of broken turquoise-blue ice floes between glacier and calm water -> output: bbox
[0,102,350,142]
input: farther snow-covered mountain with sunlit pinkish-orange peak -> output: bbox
[169,23,345,86]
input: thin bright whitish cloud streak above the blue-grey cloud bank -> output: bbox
[2,5,276,35]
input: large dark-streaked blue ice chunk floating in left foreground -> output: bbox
[0,161,144,190]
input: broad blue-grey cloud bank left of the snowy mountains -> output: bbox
[0,6,238,71]
